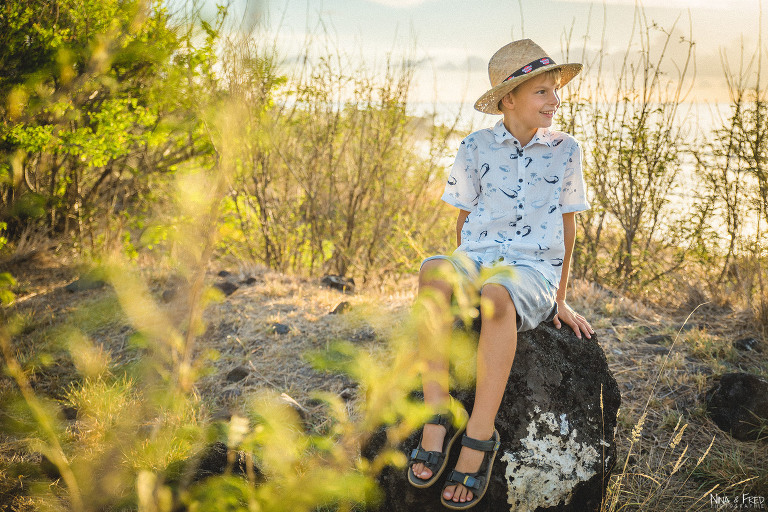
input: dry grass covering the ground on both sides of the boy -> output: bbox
[0,260,768,511]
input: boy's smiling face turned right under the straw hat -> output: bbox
[502,73,560,132]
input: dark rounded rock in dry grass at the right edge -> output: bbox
[706,373,768,441]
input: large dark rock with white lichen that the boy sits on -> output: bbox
[363,323,621,512]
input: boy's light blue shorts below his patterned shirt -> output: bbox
[421,254,557,332]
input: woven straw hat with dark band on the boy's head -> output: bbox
[475,39,581,114]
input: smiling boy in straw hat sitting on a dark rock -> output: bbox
[408,39,594,510]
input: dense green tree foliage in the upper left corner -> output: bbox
[0,0,214,250]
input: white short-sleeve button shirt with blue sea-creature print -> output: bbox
[442,120,589,286]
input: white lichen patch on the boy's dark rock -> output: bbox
[500,411,600,512]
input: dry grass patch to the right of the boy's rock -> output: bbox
[570,281,768,511]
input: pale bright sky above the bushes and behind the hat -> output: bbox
[225,0,768,115]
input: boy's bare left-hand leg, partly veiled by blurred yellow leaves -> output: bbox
[413,260,455,480]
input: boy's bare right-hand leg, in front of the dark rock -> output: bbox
[438,284,517,502]
